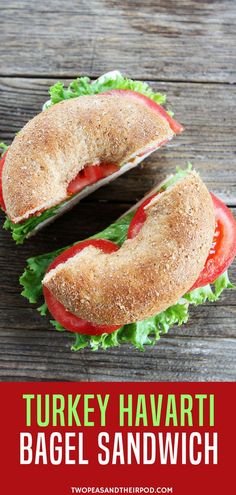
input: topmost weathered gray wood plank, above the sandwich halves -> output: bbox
[0,0,236,83]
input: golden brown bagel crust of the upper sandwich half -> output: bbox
[2,94,174,223]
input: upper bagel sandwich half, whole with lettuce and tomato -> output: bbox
[0,72,183,243]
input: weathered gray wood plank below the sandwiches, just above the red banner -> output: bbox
[0,330,236,381]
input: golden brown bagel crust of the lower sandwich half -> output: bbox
[43,172,215,325]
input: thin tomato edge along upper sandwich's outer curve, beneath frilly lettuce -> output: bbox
[102,89,184,134]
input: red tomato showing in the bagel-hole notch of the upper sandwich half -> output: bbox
[67,163,119,194]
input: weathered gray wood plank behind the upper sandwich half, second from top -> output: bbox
[0,78,236,204]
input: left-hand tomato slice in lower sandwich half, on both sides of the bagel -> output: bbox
[43,239,120,335]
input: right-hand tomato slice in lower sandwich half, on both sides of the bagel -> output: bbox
[127,193,236,290]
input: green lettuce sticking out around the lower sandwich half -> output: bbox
[20,164,234,351]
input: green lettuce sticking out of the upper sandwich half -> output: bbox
[0,71,168,244]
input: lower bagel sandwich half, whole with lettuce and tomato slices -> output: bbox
[20,169,236,350]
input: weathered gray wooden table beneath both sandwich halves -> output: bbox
[0,0,236,381]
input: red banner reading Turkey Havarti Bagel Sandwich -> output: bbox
[0,382,235,495]
